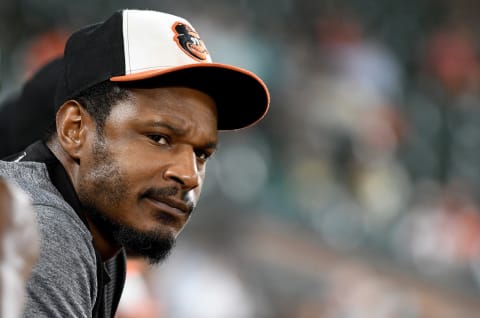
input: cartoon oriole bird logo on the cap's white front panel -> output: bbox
[172,22,209,62]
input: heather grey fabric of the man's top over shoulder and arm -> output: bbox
[0,161,97,318]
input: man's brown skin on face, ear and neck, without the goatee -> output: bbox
[48,87,218,260]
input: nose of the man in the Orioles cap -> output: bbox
[165,149,200,190]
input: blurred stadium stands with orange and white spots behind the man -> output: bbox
[0,0,480,318]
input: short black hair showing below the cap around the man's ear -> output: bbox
[46,80,131,140]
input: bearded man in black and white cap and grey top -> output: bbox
[0,10,270,318]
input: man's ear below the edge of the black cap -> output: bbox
[56,100,95,160]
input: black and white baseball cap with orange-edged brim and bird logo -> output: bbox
[55,9,270,130]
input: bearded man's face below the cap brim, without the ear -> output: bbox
[75,87,217,263]
